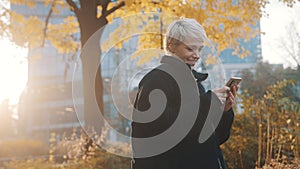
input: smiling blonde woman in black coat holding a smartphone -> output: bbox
[131,18,238,169]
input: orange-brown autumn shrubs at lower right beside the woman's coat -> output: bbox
[222,80,300,169]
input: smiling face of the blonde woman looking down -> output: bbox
[172,43,203,67]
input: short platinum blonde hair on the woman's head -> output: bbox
[164,18,207,53]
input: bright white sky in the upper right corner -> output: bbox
[261,0,300,67]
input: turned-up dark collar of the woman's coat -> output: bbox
[160,55,208,82]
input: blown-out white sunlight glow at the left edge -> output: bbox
[0,40,28,105]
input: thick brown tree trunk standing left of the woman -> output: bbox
[77,1,107,134]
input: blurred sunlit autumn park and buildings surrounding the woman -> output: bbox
[0,0,300,169]
